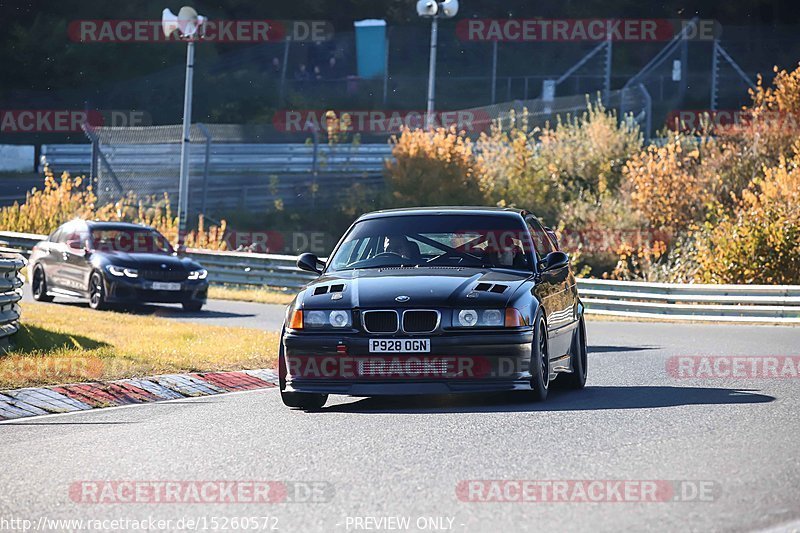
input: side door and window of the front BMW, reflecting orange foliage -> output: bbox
[525,216,576,359]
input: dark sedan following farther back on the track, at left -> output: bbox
[28,220,208,311]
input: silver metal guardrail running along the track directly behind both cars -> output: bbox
[0,232,800,324]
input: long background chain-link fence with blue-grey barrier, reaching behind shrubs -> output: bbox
[69,86,651,220]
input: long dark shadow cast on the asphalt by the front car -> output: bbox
[319,386,775,414]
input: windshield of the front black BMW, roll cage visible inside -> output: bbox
[328,215,532,272]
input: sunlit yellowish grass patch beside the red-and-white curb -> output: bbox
[0,303,279,389]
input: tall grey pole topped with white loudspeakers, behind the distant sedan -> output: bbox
[161,6,206,246]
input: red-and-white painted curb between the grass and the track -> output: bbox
[0,369,278,420]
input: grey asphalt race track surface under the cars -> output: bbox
[0,302,800,532]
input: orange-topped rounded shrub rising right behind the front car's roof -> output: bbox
[385,128,484,206]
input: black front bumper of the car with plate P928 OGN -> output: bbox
[280,329,533,396]
